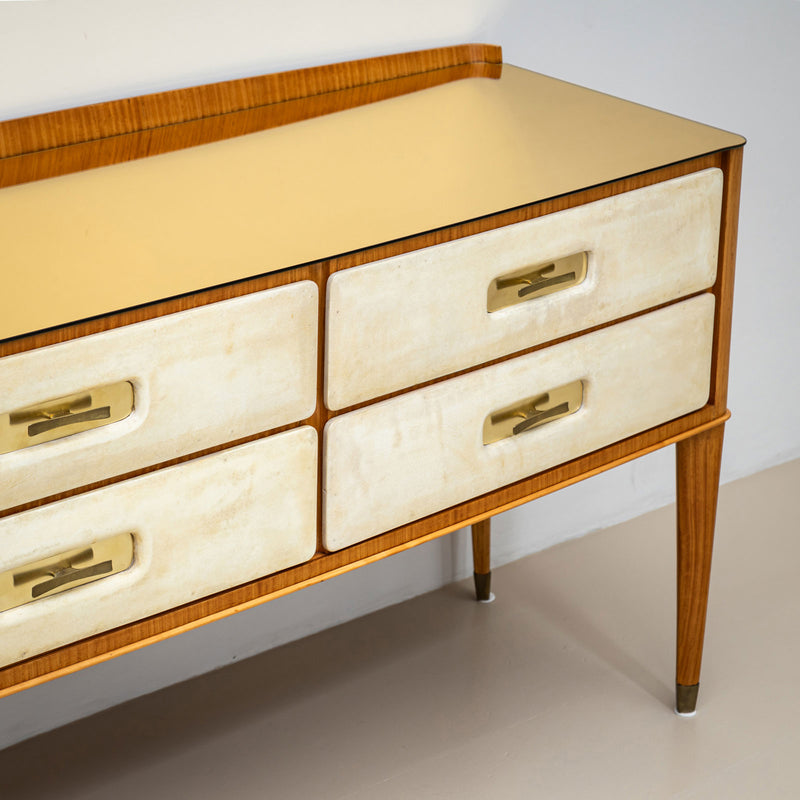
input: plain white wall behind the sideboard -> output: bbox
[0,0,800,747]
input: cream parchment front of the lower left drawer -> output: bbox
[0,426,317,664]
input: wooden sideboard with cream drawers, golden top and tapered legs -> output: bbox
[0,45,744,714]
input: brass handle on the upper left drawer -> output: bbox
[0,381,133,454]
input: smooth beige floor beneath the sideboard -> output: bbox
[0,461,800,800]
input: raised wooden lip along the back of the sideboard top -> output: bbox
[0,44,502,165]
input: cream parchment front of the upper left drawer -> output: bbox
[0,281,318,508]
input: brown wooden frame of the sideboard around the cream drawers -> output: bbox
[0,45,742,705]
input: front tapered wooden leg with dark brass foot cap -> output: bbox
[675,425,725,715]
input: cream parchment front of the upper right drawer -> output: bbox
[325,169,722,409]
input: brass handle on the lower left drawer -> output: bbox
[0,533,133,611]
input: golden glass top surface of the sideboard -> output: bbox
[0,65,744,339]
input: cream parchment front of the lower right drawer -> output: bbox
[323,294,714,550]
